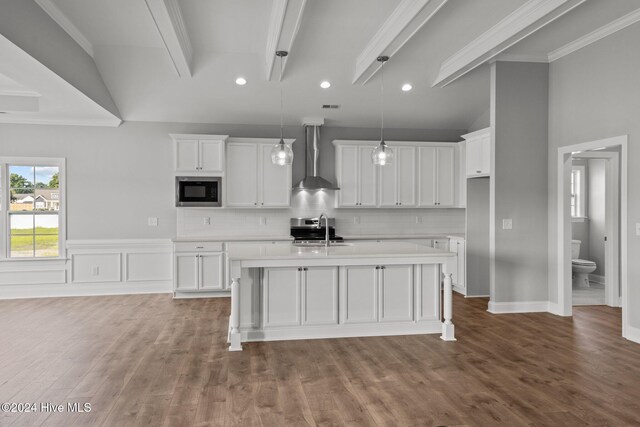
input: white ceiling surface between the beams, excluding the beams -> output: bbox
[0,0,640,129]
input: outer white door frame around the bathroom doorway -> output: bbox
[556,135,629,338]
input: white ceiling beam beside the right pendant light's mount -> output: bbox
[353,0,447,84]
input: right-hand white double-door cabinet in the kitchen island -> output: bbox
[340,265,414,323]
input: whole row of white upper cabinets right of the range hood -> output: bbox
[333,140,460,208]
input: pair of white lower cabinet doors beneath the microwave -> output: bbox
[174,252,224,292]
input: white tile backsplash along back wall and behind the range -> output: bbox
[177,192,465,238]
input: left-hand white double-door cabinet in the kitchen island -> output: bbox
[262,267,338,328]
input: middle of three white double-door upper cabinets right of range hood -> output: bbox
[378,146,416,207]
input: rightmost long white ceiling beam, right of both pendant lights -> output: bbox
[433,0,586,87]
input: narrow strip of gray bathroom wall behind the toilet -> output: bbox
[586,159,606,276]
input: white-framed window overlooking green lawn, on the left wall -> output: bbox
[0,158,65,259]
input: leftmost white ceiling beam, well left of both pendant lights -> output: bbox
[145,0,193,77]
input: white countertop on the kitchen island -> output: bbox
[227,242,456,261]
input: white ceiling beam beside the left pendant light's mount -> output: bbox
[265,0,307,81]
